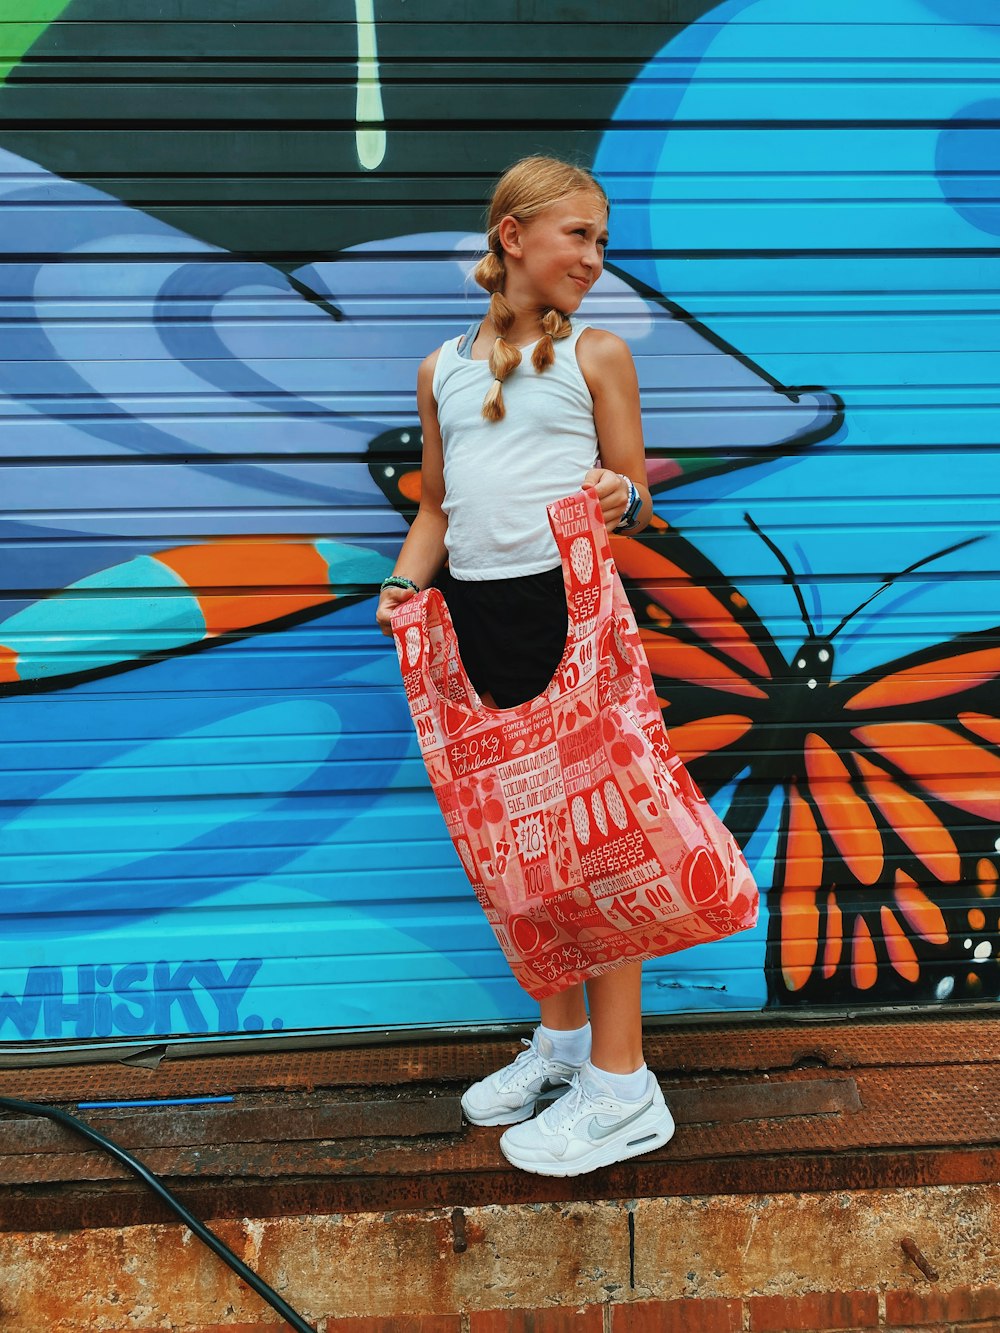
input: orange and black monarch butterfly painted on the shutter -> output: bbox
[613,515,1000,1005]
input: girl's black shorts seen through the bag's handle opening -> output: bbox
[436,565,569,708]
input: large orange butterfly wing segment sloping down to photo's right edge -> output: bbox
[853,722,1000,824]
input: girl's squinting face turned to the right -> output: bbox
[500,189,608,315]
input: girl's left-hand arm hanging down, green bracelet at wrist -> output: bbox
[375,352,448,635]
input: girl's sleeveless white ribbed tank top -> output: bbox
[433,324,597,580]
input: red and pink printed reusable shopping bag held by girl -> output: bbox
[392,491,757,998]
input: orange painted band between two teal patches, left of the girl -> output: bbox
[155,537,335,639]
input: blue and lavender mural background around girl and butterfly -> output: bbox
[0,0,1000,1041]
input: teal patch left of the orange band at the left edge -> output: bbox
[0,556,205,680]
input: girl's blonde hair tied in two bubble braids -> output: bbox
[472,157,611,421]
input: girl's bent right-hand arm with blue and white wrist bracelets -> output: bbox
[576,329,653,536]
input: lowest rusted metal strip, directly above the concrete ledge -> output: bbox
[0,1148,1000,1232]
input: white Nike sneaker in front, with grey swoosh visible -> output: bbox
[500,1060,673,1176]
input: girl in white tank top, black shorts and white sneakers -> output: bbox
[376,157,673,1176]
